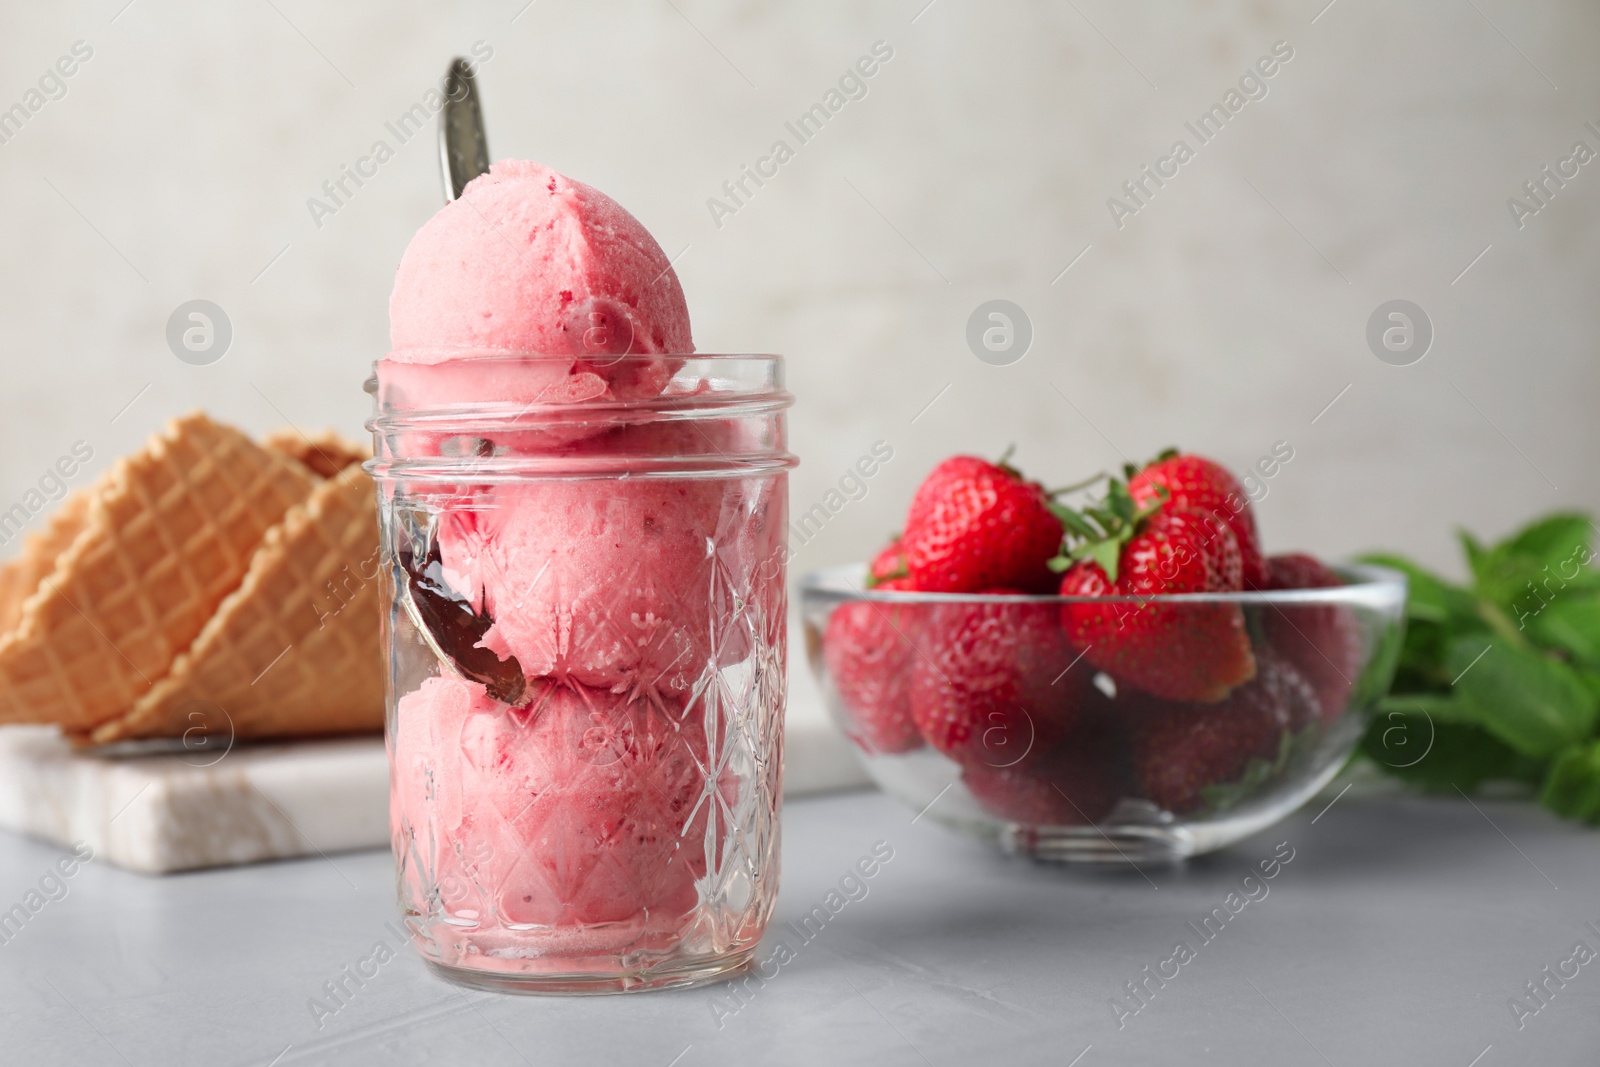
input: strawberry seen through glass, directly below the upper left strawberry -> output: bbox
[910,601,1078,768]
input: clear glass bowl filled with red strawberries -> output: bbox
[802,565,1406,864]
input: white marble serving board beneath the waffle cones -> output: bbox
[0,677,867,873]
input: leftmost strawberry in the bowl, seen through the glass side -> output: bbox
[822,577,925,753]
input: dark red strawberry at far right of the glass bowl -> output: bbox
[1261,555,1362,721]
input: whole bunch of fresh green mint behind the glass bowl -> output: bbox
[1362,512,1600,825]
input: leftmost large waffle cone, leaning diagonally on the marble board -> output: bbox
[0,414,317,734]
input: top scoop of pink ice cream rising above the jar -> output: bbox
[389,160,694,400]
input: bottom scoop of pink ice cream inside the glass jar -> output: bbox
[395,678,720,955]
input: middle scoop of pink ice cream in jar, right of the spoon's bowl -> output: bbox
[438,422,778,701]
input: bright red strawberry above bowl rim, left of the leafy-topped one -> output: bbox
[902,456,1061,593]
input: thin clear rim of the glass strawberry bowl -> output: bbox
[800,563,1408,606]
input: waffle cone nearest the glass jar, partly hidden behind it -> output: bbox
[91,466,384,747]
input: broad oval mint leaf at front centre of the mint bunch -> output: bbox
[1446,635,1600,758]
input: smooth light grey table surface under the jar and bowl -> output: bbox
[0,792,1600,1067]
